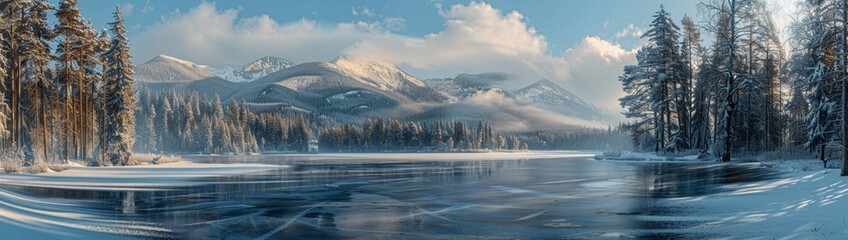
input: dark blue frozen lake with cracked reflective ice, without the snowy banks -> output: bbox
[0,154,778,239]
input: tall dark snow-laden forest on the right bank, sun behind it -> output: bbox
[619,0,848,175]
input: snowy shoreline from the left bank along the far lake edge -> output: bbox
[0,151,594,191]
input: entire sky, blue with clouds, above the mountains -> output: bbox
[66,0,797,112]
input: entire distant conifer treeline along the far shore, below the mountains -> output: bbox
[135,88,528,154]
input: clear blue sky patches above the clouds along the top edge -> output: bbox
[73,0,699,53]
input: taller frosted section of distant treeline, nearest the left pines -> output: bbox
[136,89,311,154]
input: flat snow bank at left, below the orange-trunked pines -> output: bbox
[0,161,281,191]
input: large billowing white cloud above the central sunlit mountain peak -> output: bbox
[345,2,561,79]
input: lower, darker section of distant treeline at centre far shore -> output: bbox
[318,119,527,152]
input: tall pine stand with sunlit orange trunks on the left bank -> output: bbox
[0,0,136,167]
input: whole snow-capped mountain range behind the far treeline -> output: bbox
[136,55,607,131]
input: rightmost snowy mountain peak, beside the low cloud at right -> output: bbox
[514,79,607,120]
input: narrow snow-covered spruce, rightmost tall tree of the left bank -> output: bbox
[105,7,138,166]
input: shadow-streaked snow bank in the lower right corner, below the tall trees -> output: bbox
[672,160,848,239]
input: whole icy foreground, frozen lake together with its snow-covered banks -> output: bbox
[0,152,848,239]
